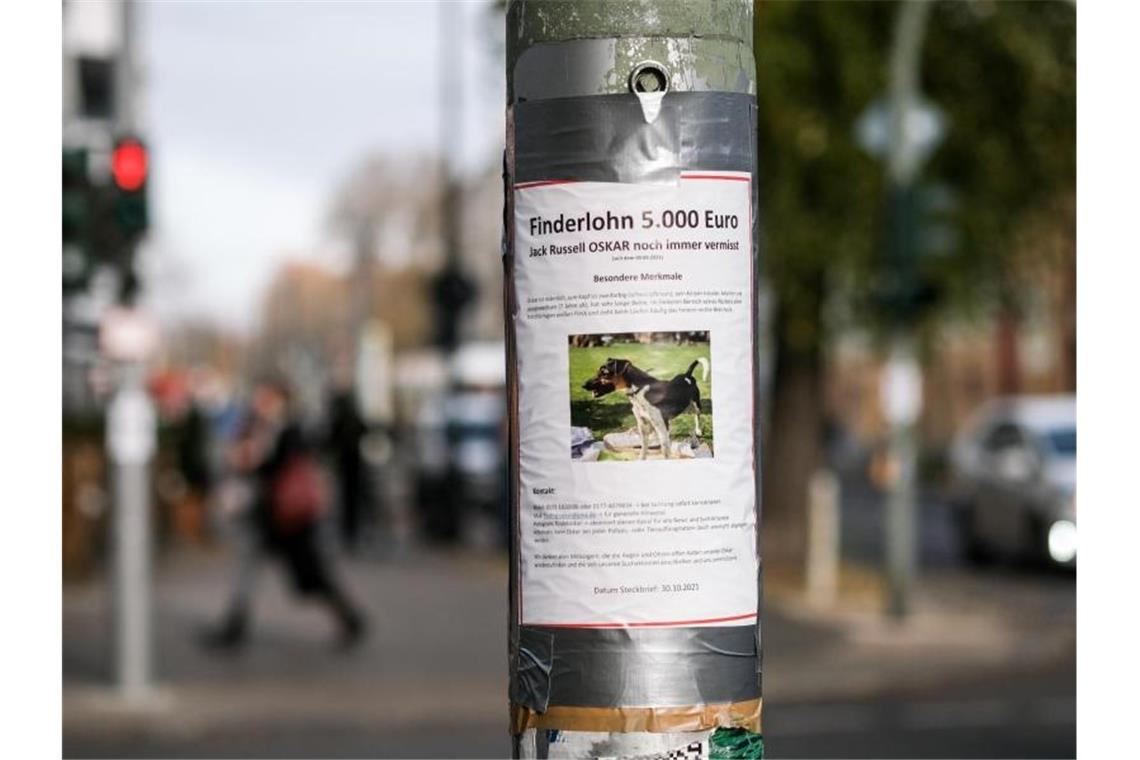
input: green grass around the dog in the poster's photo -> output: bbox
[570,343,716,451]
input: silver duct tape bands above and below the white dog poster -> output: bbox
[504,91,760,712]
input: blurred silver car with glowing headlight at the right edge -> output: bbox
[951,395,1076,567]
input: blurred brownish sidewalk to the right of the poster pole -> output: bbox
[762,566,1076,704]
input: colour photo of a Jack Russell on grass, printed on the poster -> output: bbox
[569,330,714,461]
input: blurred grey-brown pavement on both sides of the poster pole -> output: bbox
[63,551,1075,757]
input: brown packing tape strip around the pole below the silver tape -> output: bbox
[511,698,763,736]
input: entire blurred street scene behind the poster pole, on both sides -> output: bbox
[62,0,1076,758]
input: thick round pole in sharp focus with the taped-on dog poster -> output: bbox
[503,0,763,758]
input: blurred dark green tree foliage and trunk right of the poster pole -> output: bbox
[755,1,1076,561]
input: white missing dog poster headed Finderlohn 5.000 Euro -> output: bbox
[513,172,758,628]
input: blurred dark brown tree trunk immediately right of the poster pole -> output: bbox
[763,303,823,574]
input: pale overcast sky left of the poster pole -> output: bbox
[139,0,504,328]
